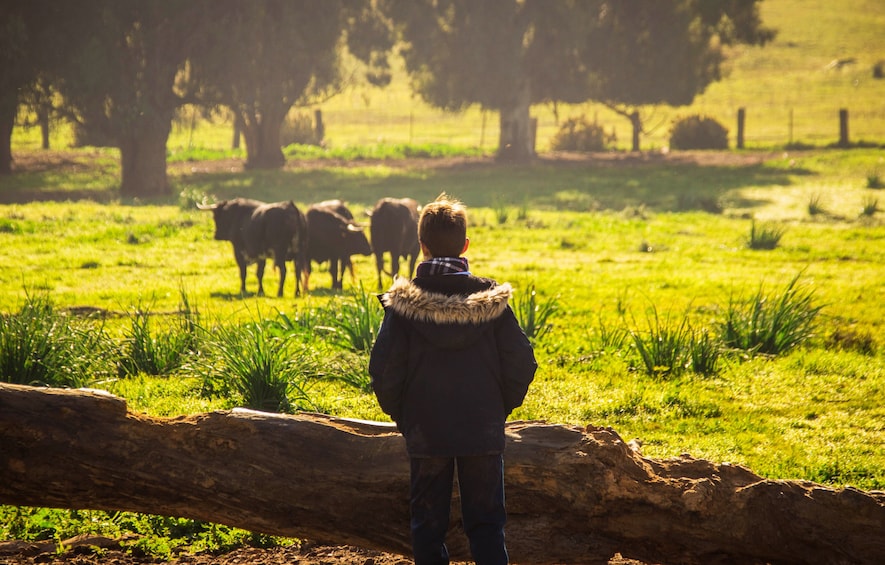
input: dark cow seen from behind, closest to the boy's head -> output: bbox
[369,198,421,290]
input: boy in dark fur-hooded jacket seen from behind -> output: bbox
[369,193,537,565]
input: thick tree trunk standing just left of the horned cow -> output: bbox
[119,114,172,198]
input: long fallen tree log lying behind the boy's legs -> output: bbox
[0,384,885,564]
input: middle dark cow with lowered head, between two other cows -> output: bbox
[305,200,372,289]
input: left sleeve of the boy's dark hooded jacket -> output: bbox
[369,312,408,424]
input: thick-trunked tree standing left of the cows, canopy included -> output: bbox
[58,0,215,198]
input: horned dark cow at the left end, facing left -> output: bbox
[198,198,307,296]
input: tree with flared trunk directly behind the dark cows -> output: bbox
[193,0,390,168]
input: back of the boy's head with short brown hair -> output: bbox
[418,192,467,257]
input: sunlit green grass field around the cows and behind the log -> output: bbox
[0,0,885,552]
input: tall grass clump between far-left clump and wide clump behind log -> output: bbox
[118,291,200,376]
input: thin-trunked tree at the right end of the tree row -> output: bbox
[586,0,774,151]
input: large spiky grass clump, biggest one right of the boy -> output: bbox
[719,273,822,355]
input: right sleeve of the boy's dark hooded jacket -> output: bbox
[496,306,538,414]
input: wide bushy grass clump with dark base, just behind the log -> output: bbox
[200,322,318,413]
